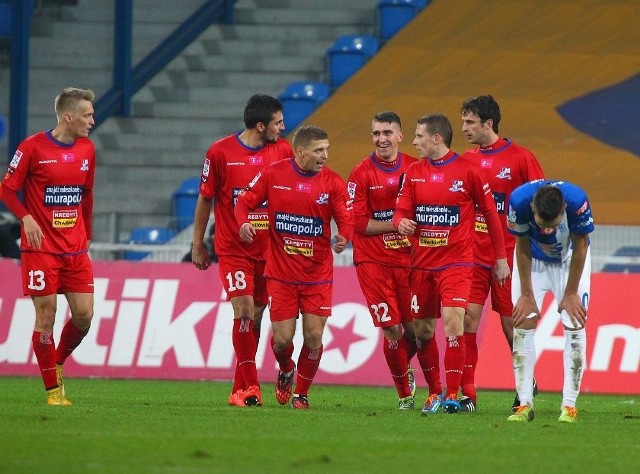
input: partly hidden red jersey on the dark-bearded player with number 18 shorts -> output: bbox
[200,133,293,260]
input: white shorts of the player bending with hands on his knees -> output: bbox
[511,247,591,328]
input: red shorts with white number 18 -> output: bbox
[218,255,268,306]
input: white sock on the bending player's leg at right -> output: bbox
[562,328,587,408]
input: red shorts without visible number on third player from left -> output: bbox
[267,279,333,322]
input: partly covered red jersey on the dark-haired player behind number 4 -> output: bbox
[463,138,544,268]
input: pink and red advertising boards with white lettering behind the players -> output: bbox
[0,259,640,394]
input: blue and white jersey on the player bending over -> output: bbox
[507,180,594,263]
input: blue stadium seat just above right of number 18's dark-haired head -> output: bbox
[278,82,330,132]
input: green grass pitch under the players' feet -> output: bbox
[0,377,640,474]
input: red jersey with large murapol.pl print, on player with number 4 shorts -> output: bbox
[393,151,505,270]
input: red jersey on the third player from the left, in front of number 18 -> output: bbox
[235,158,353,284]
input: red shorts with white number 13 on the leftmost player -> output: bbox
[21,252,93,296]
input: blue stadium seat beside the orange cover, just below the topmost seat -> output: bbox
[326,35,380,88]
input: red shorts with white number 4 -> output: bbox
[410,266,473,319]
